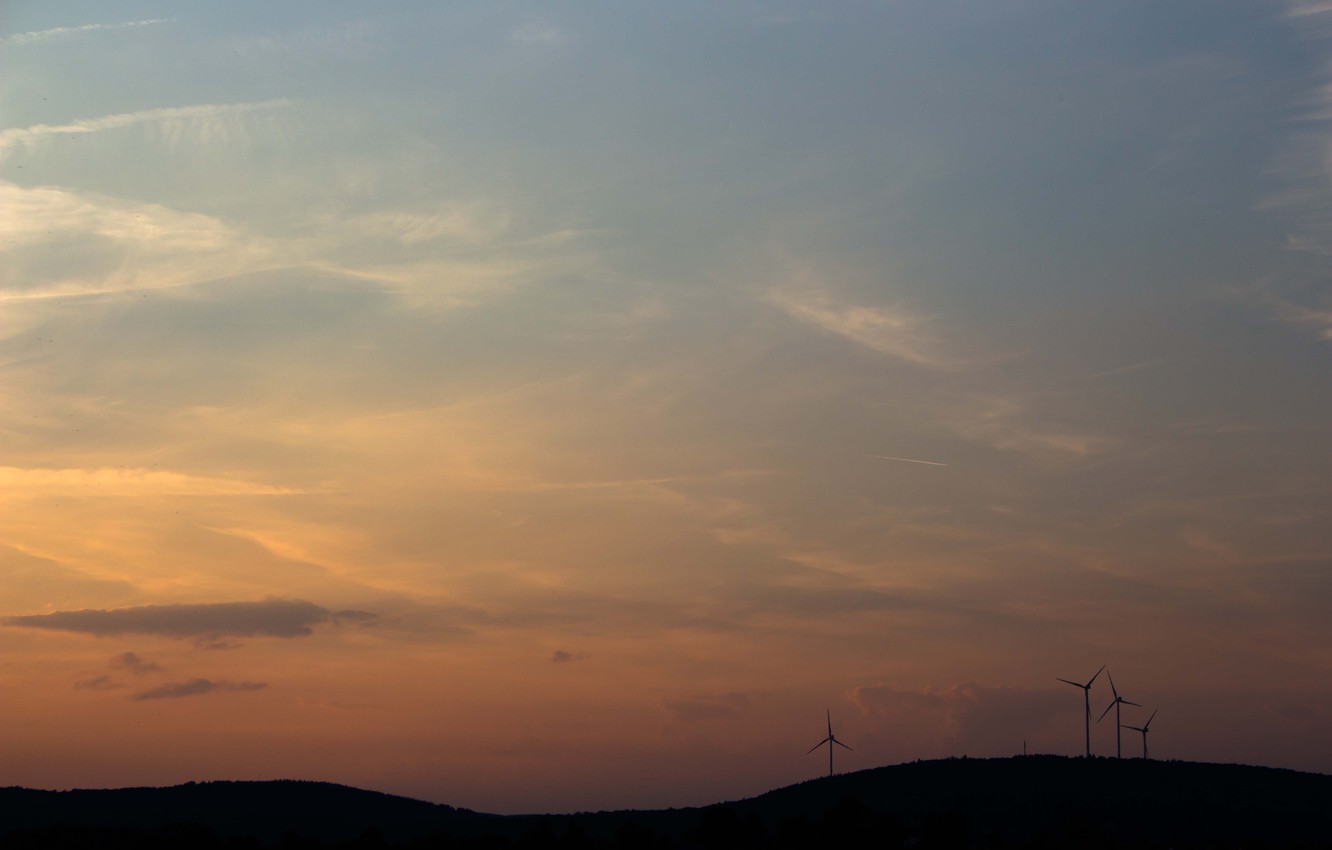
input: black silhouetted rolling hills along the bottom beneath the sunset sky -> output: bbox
[0,757,1332,850]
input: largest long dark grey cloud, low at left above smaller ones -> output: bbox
[4,600,364,645]
